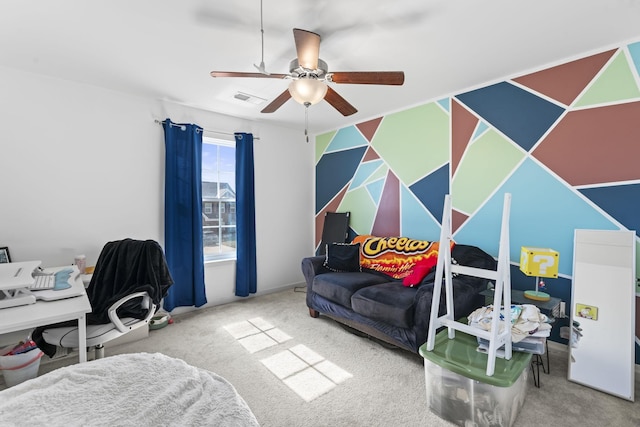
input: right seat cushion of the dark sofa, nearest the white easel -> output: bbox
[351,282,418,328]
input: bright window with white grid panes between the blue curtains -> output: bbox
[202,137,236,261]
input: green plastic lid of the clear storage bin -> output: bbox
[419,328,531,387]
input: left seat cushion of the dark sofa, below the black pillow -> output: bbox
[311,272,389,308]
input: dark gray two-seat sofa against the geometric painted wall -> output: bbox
[302,244,497,353]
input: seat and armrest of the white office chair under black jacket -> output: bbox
[42,292,156,359]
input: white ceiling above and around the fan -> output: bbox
[0,0,640,133]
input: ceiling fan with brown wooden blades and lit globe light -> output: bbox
[211,28,404,116]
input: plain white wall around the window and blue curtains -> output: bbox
[0,67,314,305]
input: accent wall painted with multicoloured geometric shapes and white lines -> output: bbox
[316,42,640,363]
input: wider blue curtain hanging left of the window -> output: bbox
[162,119,207,311]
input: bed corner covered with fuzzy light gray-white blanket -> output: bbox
[0,353,258,427]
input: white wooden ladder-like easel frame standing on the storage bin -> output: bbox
[427,193,512,376]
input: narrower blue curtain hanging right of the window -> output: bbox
[235,133,257,297]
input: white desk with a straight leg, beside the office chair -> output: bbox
[0,269,91,363]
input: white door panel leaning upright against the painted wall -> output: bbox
[568,230,636,401]
